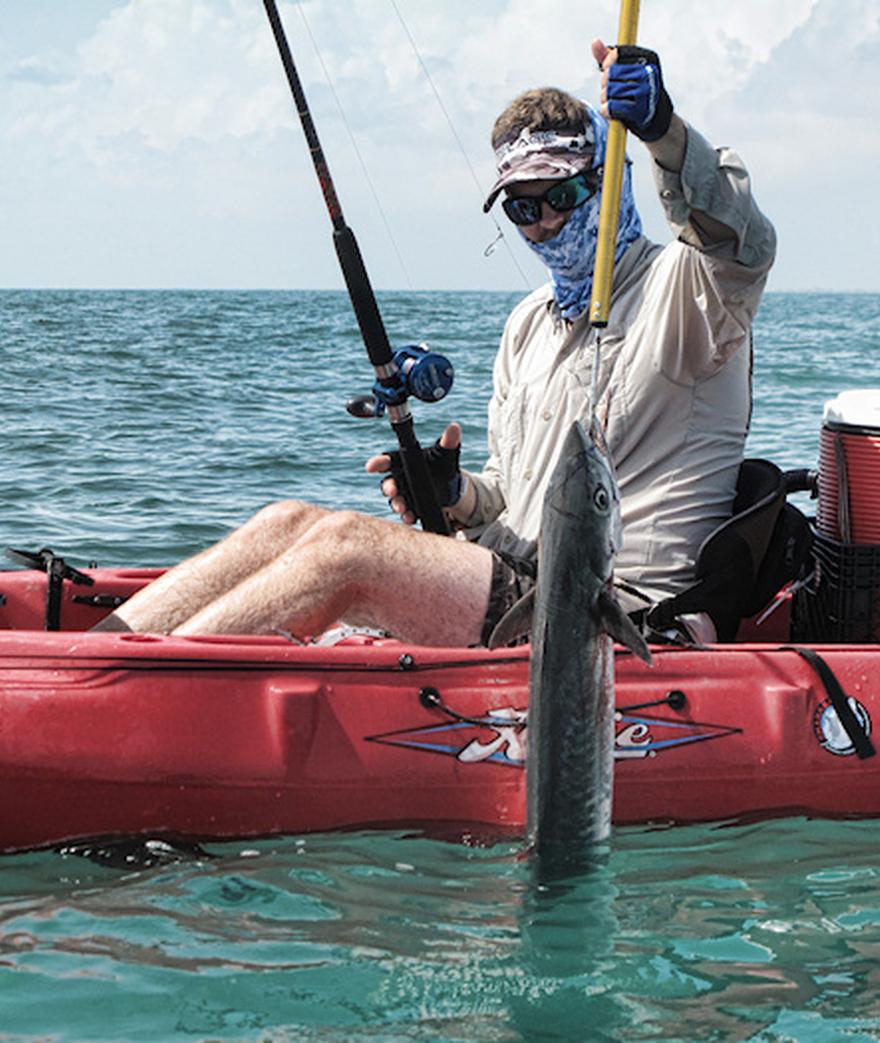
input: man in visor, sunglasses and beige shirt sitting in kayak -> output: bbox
[94,41,775,646]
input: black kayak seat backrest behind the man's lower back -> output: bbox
[645,459,815,641]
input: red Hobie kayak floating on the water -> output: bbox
[0,569,880,851]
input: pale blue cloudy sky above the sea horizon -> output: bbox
[0,0,880,291]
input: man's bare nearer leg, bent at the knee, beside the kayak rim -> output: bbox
[174,511,492,646]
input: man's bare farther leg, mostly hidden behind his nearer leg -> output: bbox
[95,500,327,634]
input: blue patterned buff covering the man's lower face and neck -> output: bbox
[517,102,641,319]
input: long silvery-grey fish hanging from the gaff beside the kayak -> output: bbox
[489,421,651,870]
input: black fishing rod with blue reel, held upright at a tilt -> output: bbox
[263,0,451,535]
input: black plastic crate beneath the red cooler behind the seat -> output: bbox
[791,532,880,644]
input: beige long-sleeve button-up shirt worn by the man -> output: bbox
[468,128,776,598]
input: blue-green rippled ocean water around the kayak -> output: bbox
[0,291,880,1043]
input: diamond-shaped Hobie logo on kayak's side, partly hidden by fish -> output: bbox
[366,706,740,768]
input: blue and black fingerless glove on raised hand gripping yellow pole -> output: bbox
[607,44,673,141]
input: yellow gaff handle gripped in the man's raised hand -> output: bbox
[590,0,639,326]
